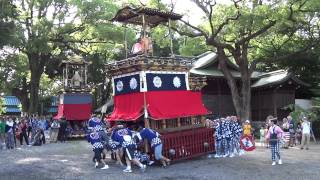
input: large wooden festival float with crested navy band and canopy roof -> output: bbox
[106,6,214,160]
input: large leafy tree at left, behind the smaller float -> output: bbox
[9,0,124,113]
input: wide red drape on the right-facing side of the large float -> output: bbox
[146,90,209,119]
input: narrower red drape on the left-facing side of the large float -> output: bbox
[107,92,144,121]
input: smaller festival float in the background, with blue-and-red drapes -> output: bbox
[53,55,92,137]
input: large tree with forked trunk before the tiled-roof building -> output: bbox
[174,0,319,120]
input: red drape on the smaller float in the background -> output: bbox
[53,104,91,121]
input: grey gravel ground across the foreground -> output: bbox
[0,141,320,180]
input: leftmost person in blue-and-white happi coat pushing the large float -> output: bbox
[87,128,109,169]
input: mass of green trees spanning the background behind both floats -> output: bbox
[0,0,320,115]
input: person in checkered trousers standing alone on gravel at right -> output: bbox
[266,118,283,166]
